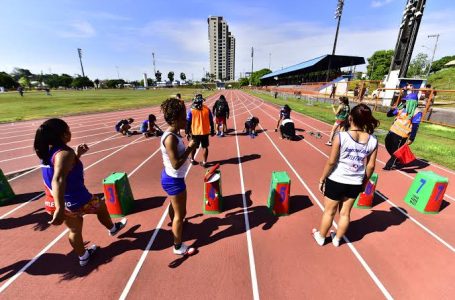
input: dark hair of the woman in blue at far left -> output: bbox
[33,118,69,165]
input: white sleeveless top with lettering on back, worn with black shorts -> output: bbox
[329,132,378,185]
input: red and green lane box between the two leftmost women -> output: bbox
[103,173,134,217]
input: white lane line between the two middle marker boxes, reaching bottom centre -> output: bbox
[231,91,259,300]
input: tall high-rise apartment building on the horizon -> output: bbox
[207,17,235,81]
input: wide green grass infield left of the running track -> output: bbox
[0,88,212,122]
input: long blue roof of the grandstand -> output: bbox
[261,54,365,79]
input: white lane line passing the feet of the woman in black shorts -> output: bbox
[237,91,393,299]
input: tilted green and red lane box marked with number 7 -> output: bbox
[404,171,449,214]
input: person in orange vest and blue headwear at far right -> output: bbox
[383,91,422,170]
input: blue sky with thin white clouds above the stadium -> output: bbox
[0,0,455,80]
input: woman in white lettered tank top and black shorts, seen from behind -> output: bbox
[312,104,379,247]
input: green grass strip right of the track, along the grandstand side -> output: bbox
[249,92,455,170]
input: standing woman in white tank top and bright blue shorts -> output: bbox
[160,98,197,255]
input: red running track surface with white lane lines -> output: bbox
[0,91,455,299]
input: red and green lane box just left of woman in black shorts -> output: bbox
[267,172,291,216]
